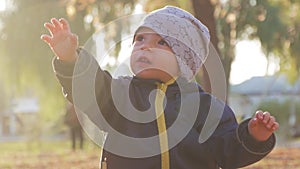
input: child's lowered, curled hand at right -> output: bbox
[248,110,279,141]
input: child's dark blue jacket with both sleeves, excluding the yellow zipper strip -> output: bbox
[53,48,275,169]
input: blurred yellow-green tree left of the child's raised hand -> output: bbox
[0,0,65,123]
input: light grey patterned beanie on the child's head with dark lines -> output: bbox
[135,6,210,81]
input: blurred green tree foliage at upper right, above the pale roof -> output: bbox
[216,0,300,82]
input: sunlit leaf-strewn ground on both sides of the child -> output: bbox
[0,141,300,169]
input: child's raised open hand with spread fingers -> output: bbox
[41,18,78,62]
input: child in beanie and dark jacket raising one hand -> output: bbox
[41,6,279,169]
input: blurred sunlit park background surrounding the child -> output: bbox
[0,0,300,168]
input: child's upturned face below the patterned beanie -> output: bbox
[130,27,179,82]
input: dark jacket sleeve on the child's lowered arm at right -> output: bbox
[198,94,276,169]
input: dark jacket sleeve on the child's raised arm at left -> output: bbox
[53,49,113,130]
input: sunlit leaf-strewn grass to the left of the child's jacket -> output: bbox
[0,141,101,169]
